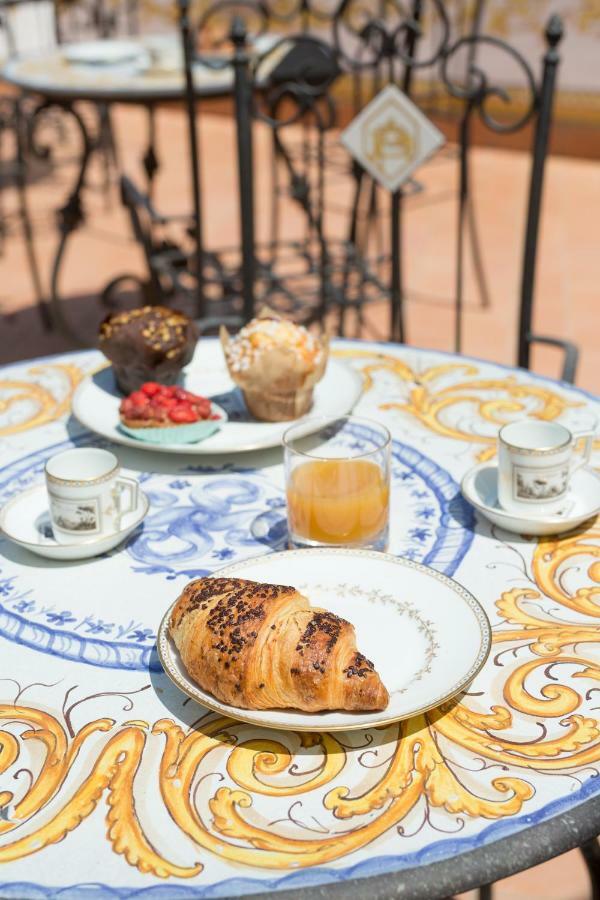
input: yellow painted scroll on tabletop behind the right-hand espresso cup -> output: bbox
[335,348,585,462]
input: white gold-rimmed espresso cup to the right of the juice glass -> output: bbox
[498,419,596,518]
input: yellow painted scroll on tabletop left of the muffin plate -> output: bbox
[0,363,83,437]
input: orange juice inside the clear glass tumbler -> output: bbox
[287,459,390,544]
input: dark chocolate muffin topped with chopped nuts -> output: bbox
[99,306,198,394]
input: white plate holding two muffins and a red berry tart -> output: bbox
[73,341,363,455]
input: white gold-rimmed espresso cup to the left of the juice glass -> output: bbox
[46,447,138,544]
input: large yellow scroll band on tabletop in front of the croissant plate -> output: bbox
[0,523,600,878]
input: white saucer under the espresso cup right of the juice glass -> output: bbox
[460,463,600,537]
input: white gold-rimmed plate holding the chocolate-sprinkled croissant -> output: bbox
[157,548,491,731]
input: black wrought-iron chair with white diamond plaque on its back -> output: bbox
[196,0,577,381]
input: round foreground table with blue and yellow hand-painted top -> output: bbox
[0,341,600,900]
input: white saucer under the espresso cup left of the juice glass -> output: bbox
[0,484,150,560]
